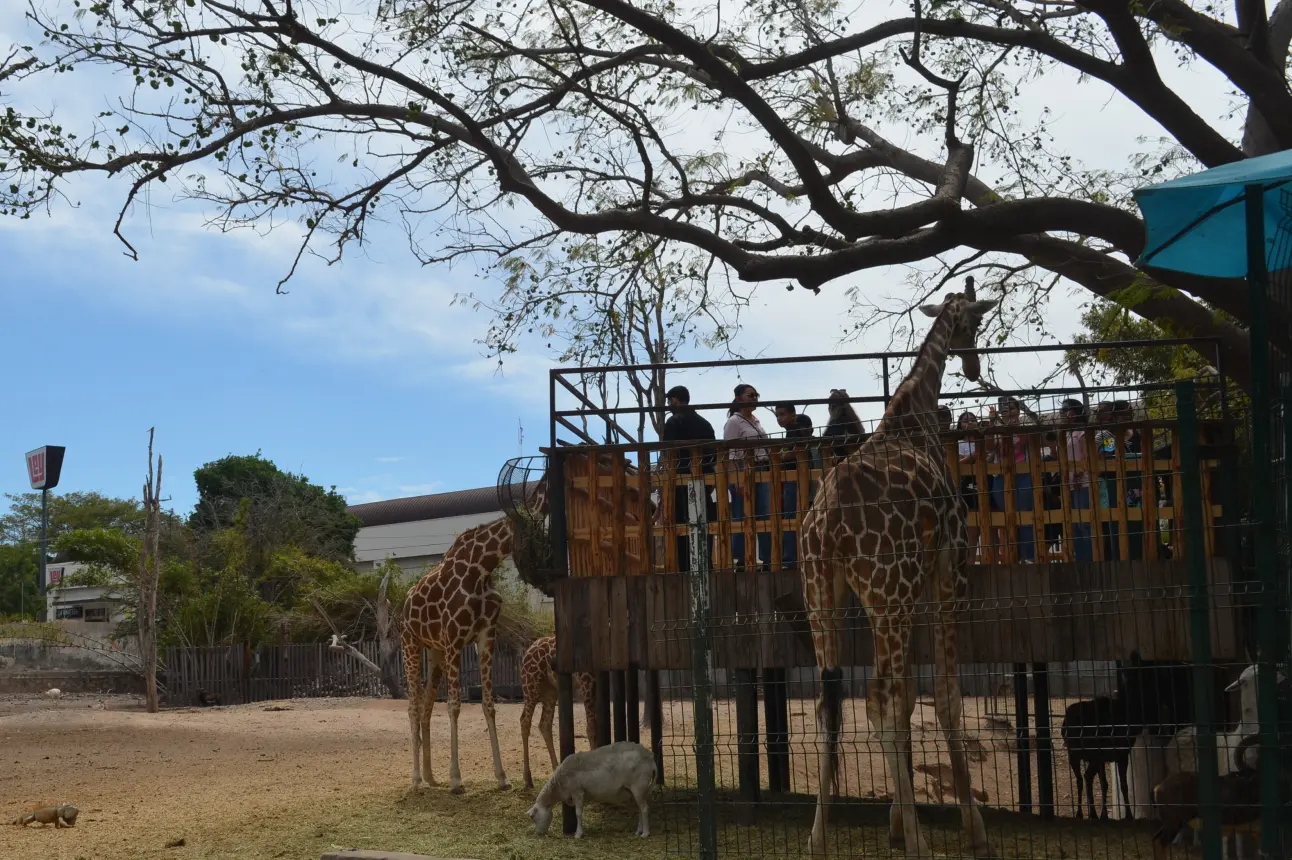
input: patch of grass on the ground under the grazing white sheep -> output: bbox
[164,785,1152,860]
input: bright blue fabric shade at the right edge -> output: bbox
[1134,150,1292,278]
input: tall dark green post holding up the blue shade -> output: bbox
[1244,185,1283,857]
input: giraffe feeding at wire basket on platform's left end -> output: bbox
[399,455,641,794]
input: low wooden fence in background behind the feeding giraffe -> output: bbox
[158,642,522,705]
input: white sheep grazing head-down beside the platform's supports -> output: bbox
[528,741,655,839]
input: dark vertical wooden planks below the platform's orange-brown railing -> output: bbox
[556,558,1243,671]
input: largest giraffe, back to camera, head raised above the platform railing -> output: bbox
[802,278,996,857]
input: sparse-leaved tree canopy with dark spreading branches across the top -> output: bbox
[0,0,1292,380]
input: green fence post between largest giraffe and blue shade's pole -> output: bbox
[1176,382,1221,860]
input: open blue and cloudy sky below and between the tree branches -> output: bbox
[0,3,1226,511]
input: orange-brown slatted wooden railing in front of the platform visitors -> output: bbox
[552,420,1225,576]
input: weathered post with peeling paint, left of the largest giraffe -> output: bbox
[687,480,718,860]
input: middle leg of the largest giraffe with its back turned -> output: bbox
[866,606,932,857]
